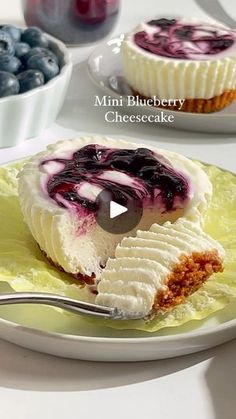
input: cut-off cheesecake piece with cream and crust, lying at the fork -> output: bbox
[96,218,225,317]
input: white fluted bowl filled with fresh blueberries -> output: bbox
[0,24,72,148]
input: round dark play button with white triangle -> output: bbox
[96,189,143,234]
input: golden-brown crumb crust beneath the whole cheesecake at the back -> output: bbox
[132,89,236,113]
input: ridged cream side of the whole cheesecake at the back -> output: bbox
[121,33,236,99]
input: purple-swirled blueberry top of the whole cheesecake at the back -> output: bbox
[134,18,236,60]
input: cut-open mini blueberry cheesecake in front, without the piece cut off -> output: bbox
[19,136,212,285]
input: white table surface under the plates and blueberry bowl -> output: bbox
[0,0,236,419]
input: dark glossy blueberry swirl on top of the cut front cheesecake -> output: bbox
[41,144,190,214]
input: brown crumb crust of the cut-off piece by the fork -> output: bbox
[153,250,223,312]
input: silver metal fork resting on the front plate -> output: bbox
[0,292,143,320]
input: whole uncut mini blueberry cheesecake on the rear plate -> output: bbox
[122,18,236,113]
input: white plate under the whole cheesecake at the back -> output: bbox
[88,34,236,134]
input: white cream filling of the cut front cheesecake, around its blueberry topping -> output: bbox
[19,136,212,276]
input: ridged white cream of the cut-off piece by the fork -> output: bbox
[96,218,224,316]
